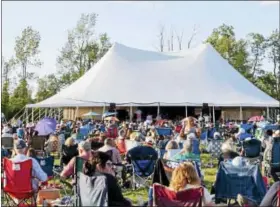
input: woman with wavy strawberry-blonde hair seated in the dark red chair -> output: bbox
[169,162,213,206]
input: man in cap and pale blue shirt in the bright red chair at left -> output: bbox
[11,139,48,191]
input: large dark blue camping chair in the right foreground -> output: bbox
[215,162,266,205]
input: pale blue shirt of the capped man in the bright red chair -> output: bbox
[11,154,48,191]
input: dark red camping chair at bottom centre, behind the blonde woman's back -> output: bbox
[153,183,204,207]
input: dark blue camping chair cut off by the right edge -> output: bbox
[264,137,280,180]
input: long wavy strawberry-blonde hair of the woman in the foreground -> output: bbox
[169,162,201,192]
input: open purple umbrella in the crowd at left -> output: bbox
[35,118,56,136]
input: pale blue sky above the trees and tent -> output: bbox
[2,1,280,92]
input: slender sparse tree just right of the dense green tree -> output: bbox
[248,33,266,78]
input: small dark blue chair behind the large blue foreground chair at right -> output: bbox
[242,138,262,164]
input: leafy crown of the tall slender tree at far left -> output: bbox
[14,26,42,80]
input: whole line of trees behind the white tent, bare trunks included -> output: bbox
[1,13,280,119]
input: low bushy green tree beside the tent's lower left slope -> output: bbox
[36,74,60,102]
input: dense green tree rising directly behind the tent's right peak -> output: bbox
[206,24,250,78]
